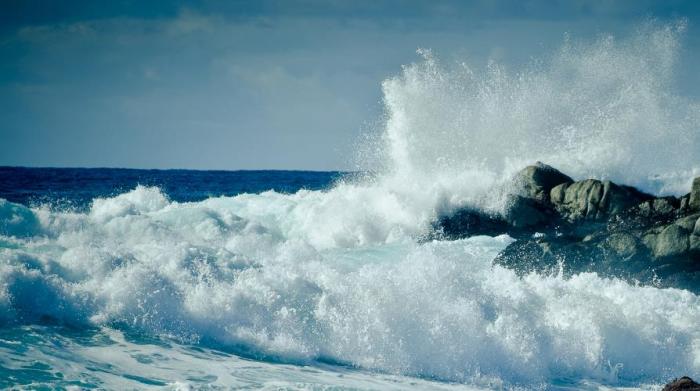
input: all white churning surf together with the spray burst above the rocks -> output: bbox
[0,25,700,389]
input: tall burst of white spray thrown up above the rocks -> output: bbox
[376,22,700,199]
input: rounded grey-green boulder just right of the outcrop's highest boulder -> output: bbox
[550,179,653,222]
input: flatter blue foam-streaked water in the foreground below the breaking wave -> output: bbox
[0,326,484,390]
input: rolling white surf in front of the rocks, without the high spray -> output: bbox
[0,187,700,385]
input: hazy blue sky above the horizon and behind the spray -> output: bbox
[0,0,700,170]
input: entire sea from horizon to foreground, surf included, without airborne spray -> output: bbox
[0,168,700,389]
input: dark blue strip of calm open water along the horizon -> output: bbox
[0,167,343,210]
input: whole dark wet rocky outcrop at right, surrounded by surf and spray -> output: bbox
[436,163,700,292]
